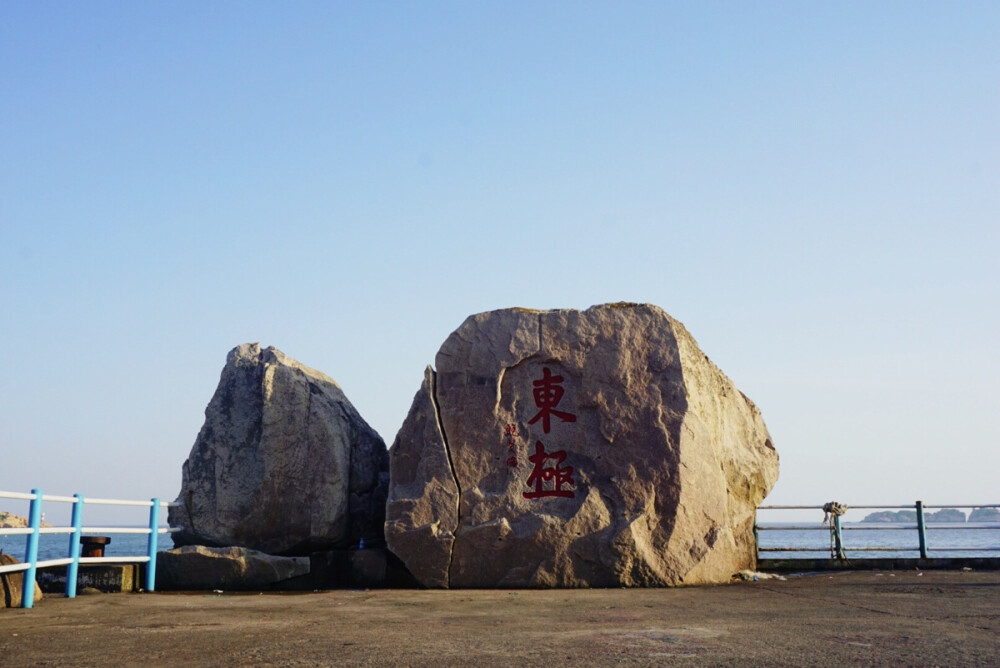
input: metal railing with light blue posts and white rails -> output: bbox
[0,489,179,608]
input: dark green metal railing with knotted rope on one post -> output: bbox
[754,501,1000,560]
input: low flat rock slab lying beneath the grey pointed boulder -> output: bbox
[156,545,309,591]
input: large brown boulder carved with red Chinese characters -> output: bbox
[386,304,778,587]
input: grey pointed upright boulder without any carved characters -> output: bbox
[169,343,388,554]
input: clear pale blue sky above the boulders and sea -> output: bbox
[0,0,1000,519]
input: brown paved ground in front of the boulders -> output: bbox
[0,571,1000,667]
